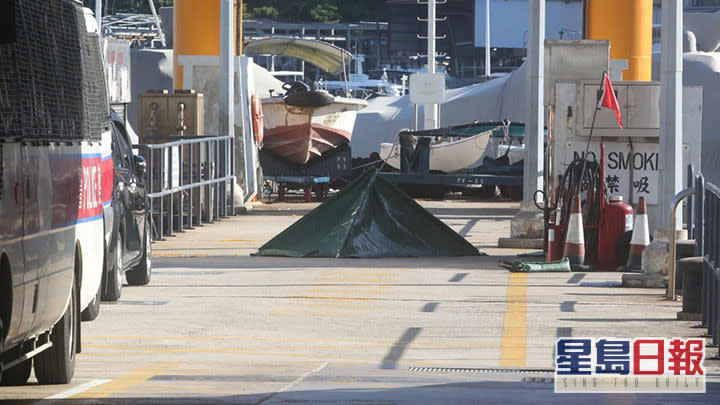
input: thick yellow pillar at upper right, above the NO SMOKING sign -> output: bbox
[585,0,653,81]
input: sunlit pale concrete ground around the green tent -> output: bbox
[0,195,720,404]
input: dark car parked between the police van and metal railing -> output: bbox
[102,114,152,301]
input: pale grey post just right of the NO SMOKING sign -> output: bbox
[659,0,683,230]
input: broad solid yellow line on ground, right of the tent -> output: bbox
[500,273,527,367]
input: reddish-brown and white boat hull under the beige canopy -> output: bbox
[263,97,367,164]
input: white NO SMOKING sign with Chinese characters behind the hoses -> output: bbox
[565,142,660,205]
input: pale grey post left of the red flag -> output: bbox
[523,0,545,204]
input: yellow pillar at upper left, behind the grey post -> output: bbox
[173,0,237,89]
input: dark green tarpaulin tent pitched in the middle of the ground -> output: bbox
[258,169,479,257]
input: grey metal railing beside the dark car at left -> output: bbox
[134,136,235,240]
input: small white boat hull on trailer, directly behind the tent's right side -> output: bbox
[380,130,493,173]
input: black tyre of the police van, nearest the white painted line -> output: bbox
[34,266,80,384]
